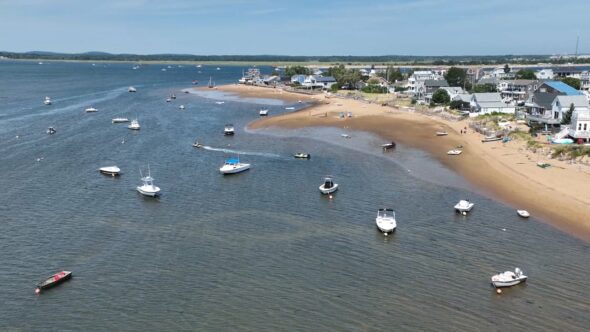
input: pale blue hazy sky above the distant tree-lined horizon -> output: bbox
[0,0,590,55]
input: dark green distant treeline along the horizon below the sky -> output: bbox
[0,51,589,66]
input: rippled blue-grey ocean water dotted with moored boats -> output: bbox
[0,61,590,331]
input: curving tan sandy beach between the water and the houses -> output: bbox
[208,85,590,241]
